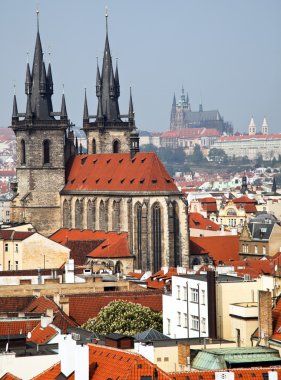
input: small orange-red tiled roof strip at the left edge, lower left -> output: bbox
[0,318,41,335]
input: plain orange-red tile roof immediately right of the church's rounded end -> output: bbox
[190,235,239,264]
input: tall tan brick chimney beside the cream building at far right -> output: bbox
[258,290,272,346]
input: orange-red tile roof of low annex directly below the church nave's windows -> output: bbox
[50,228,132,263]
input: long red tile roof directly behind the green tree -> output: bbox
[69,290,163,325]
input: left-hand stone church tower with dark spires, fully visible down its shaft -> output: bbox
[11,16,74,235]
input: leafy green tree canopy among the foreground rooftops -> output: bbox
[82,300,162,336]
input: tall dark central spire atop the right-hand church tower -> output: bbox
[96,11,121,122]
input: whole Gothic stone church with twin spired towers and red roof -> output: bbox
[12,19,189,272]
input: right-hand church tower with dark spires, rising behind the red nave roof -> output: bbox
[83,14,139,154]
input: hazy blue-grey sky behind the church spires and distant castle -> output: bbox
[0,0,281,132]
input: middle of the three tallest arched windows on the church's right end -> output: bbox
[151,203,162,272]
